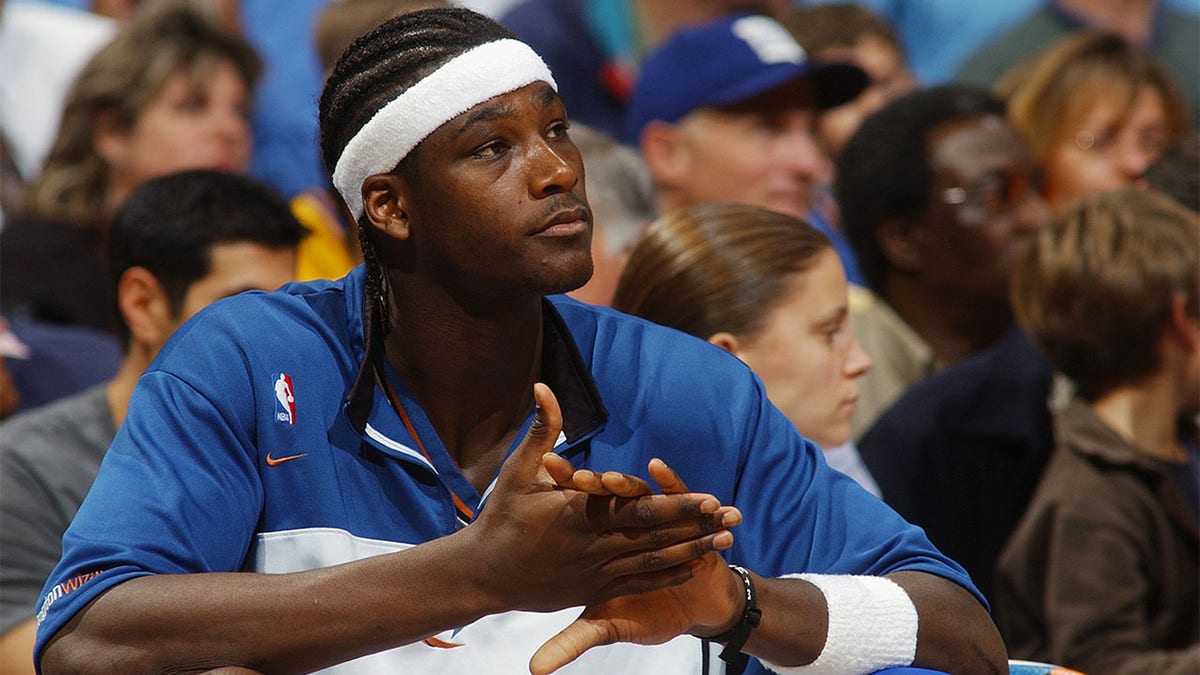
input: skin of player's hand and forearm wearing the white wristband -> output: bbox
[530,455,1008,675]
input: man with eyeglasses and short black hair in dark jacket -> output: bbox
[836,85,1052,595]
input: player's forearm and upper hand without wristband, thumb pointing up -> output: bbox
[41,384,740,673]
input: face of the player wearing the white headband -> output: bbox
[391,82,592,299]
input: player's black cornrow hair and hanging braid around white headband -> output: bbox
[319,7,515,426]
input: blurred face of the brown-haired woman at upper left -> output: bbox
[96,61,251,202]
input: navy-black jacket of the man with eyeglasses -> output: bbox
[858,328,1054,598]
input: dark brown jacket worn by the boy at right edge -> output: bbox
[995,400,1200,675]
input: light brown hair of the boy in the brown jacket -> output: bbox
[1012,187,1200,400]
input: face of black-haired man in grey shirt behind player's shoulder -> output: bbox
[166,241,296,336]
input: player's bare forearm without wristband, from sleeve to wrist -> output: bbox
[42,531,505,673]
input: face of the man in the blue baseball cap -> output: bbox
[656,80,829,217]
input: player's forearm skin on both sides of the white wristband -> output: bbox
[744,572,1007,675]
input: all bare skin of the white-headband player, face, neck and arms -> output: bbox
[46,83,1006,675]
